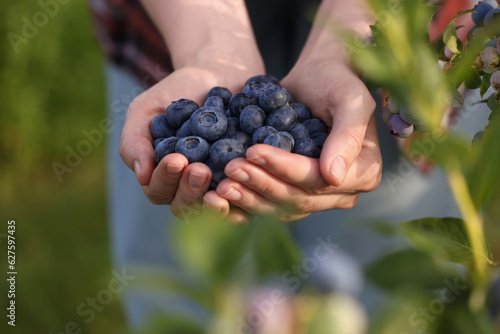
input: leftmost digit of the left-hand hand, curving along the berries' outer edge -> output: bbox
[119,98,163,186]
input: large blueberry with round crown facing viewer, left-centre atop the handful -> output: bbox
[189,107,227,142]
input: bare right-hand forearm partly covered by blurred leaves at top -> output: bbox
[299,0,373,63]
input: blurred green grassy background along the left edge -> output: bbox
[0,0,125,334]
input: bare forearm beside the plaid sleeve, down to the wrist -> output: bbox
[141,0,263,69]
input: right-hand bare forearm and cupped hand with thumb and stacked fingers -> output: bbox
[205,0,382,221]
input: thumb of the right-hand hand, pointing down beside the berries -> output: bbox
[320,97,375,187]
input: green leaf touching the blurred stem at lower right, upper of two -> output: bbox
[401,217,493,265]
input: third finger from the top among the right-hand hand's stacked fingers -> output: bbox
[216,179,279,216]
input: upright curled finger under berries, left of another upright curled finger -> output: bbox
[143,153,188,204]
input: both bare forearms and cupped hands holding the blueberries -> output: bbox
[120,0,382,223]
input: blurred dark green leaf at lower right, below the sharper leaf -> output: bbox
[366,249,456,290]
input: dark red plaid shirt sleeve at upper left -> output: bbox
[89,0,172,88]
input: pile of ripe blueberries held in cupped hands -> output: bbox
[151,74,328,187]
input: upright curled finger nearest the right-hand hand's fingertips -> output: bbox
[171,162,212,219]
